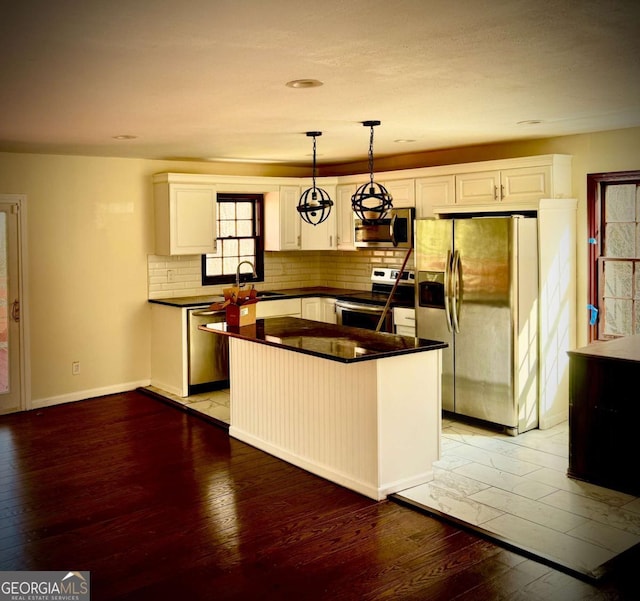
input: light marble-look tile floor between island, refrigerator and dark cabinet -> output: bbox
[395,419,640,578]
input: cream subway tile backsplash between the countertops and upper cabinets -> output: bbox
[147,250,413,299]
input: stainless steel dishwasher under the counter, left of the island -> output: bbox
[187,307,229,395]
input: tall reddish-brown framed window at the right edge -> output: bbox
[587,172,640,341]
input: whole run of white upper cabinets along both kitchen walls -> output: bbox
[153,154,572,255]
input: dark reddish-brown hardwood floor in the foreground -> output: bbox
[0,391,640,601]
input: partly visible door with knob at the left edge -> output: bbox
[0,195,24,413]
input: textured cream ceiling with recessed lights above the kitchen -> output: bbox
[0,0,640,165]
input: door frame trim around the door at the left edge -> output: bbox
[0,194,32,411]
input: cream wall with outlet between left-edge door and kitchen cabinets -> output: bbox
[0,153,303,407]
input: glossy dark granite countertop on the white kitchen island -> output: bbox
[199,317,447,363]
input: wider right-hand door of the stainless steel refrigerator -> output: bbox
[452,217,518,427]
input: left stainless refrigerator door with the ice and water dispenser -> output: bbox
[415,219,455,411]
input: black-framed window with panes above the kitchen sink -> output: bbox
[202,194,264,286]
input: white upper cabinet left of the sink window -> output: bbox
[153,173,217,256]
